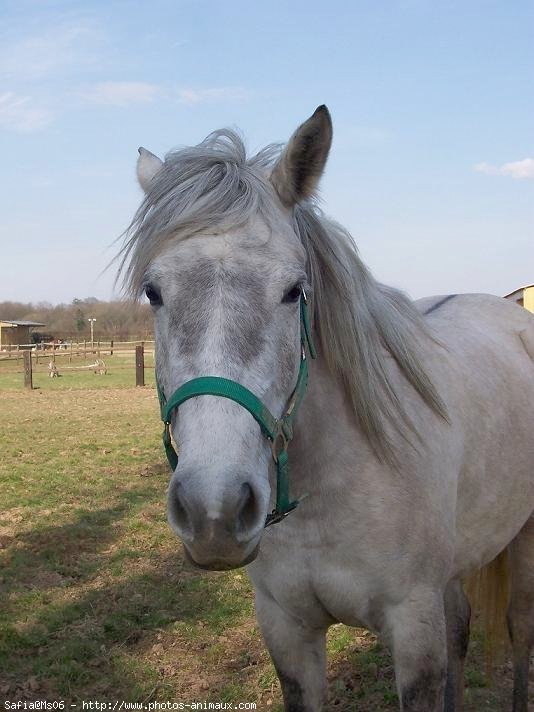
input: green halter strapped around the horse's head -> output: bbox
[156,290,316,527]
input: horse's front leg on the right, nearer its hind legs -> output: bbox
[385,589,447,712]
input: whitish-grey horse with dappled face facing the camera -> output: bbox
[118,106,534,712]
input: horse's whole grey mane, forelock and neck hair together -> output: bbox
[119,129,446,463]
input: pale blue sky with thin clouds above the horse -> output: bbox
[0,0,534,303]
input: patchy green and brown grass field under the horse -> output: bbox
[0,384,528,712]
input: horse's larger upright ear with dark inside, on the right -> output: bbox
[271,104,332,208]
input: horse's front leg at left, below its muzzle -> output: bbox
[256,591,326,712]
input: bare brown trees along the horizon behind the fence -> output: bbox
[0,297,154,341]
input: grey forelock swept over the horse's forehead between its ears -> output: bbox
[118,129,281,298]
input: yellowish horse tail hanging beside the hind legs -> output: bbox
[466,549,510,680]
